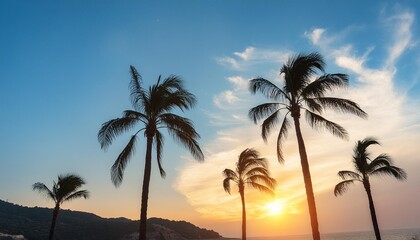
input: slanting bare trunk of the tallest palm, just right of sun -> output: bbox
[293,117,321,240]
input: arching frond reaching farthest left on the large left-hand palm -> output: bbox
[98,117,139,149]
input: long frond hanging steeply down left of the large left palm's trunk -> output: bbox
[111,135,137,187]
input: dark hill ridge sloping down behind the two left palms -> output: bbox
[0,200,222,240]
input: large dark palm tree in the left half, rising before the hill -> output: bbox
[98,66,204,240]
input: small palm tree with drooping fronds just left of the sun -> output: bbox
[223,148,276,240]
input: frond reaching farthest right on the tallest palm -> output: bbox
[308,97,367,118]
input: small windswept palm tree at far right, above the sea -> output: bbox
[334,137,407,240]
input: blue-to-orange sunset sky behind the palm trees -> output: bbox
[0,0,420,237]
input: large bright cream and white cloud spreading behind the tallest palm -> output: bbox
[176,8,420,227]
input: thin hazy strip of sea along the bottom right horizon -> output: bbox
[247,229,420,240]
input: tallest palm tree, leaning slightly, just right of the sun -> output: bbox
[249,53,367,240]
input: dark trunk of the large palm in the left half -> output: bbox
[139,136,153,240]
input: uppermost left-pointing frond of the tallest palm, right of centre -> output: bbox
[249,78,290,101]
